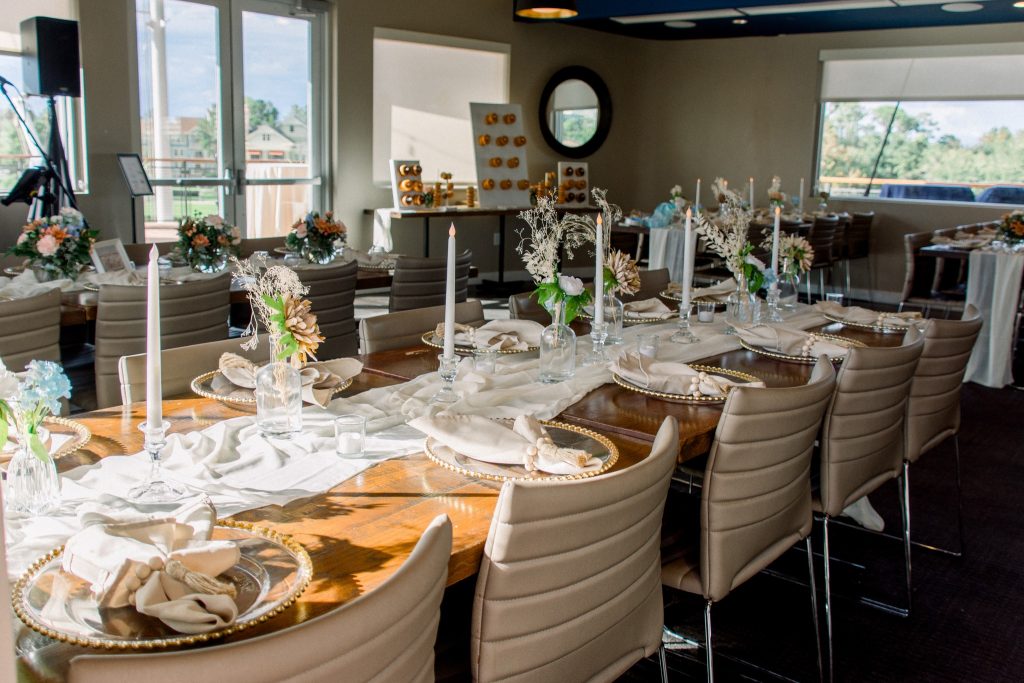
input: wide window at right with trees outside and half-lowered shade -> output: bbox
[818,43,1024,204]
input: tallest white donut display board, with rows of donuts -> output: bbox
[469,102,529,209]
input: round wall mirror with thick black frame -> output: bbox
[540,67,611,159]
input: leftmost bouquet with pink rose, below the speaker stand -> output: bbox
[7,209,98,281]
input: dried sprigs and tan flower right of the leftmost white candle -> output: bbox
[234,258,324,367]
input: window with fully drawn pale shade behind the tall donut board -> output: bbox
[374,29,510,185]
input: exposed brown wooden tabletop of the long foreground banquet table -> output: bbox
[16,325,901,681]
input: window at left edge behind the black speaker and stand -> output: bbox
[0,0,88,195]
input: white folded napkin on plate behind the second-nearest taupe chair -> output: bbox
[409,415,601,474]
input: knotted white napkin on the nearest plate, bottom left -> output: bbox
[61,500,241,633]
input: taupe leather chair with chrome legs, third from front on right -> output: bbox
[662,356,836,681]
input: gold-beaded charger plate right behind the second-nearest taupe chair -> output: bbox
[424,420,618,481]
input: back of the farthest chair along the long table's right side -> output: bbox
[903,304,982,463]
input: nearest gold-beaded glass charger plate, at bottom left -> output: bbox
[11,520,312,651]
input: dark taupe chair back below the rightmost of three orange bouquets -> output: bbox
[295,261,359,360]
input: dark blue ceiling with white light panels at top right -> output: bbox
[516,0,1024,40]
